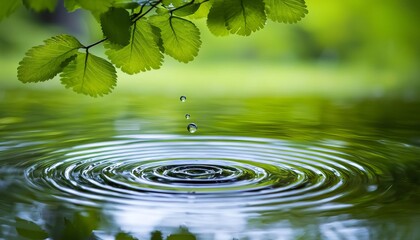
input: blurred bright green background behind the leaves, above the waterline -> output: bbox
[0,0,420,100]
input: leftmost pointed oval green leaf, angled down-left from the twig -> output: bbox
[18,35,83,83]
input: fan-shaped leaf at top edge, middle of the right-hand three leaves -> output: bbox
[224,0,267,36]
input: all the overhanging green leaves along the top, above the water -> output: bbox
[0,0,308,97]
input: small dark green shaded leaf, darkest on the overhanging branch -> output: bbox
[101,8,131,46]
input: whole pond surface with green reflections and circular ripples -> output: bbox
[0,91,420,240]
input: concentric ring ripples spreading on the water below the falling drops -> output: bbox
[25,135,392,212]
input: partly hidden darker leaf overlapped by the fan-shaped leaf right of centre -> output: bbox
[207,0,229,36]
